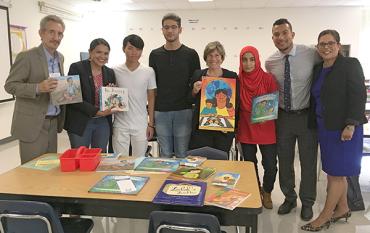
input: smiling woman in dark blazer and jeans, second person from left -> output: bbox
[64,38,116,152]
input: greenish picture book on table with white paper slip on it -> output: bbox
[89,175,149,194]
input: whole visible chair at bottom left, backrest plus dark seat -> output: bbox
[0,200,94,233]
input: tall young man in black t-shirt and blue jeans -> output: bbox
[149,13,200,157]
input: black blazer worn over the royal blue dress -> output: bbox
[309,55,367,130]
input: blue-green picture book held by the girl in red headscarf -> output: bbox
[251,92,279,123]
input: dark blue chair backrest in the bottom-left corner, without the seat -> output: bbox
[0,200,64,233]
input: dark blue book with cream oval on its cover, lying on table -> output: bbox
[153,180,207,206]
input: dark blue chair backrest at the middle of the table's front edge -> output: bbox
[148,211,221,233]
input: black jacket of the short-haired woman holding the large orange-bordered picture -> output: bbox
[188,69,239,134]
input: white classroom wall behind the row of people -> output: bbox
[0,0,370,139]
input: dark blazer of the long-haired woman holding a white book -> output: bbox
[64,60,116,136]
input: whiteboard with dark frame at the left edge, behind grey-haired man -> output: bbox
[0,6,14,102]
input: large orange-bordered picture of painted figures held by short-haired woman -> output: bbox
[199,76,236,132]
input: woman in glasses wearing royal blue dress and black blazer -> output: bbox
[301,30,367,231]
